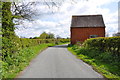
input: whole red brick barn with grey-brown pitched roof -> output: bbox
[71,15,105,44]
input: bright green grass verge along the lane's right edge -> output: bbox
[68,47,120,80]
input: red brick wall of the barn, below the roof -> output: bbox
[71,27,105,44]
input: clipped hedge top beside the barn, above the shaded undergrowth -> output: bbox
[84,37,120,56]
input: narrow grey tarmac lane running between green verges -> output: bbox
[18,45,103,78]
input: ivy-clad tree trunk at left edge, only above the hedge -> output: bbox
[2,2,15,38]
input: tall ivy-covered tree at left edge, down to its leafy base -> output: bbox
[0,2,19,59]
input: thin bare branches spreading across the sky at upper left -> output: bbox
[11,0,68,21]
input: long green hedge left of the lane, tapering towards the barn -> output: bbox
[2,36,69,58]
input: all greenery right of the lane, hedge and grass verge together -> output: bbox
[69,37,120,78]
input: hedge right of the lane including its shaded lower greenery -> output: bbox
[84,37,120,63]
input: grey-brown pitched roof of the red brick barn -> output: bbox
[71,15,105,27]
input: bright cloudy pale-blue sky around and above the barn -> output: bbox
[15,0,119,38]
